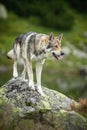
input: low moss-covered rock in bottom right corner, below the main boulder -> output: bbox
[45,110,87,130]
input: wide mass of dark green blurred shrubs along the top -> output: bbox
[0,0,74,30]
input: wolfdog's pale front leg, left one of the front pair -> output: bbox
[26,60,35,90]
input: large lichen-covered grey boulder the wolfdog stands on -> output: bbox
[0,78,87,130]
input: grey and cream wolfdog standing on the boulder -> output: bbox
[7,32,64,96]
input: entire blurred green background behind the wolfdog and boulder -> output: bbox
[0,0,87,99]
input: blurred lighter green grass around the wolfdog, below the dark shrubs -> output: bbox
[0,12,87,98]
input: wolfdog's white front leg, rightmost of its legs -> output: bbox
[36,61,44,96]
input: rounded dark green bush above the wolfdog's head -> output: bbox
[42,7,74,30]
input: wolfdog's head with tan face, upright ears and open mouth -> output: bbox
[47,33,64,60]
